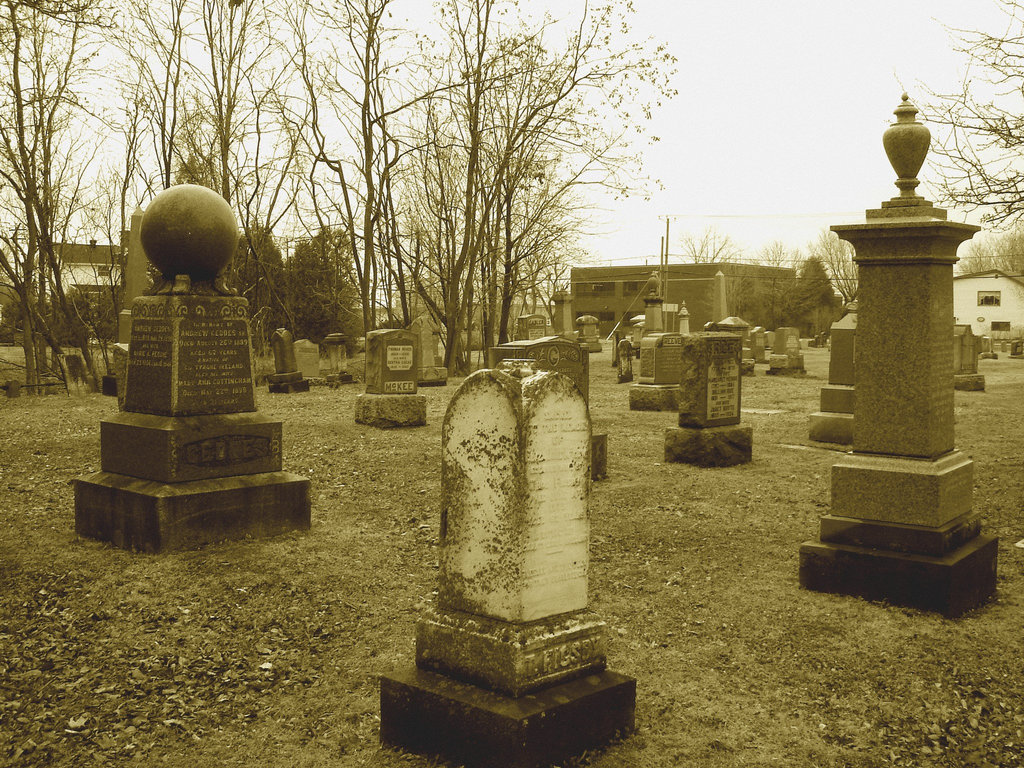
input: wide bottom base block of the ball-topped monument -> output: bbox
[75,472,309,552]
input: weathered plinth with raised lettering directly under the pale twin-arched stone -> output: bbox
[416,610,606,696]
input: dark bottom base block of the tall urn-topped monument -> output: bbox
[800,536,998,618]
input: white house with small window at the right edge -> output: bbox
[953,269,1024,339]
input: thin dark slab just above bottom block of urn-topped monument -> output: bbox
[818,513,981,556]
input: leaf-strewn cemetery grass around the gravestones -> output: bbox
[0,349,1024,768]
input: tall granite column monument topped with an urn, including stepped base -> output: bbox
[800,94,997,616]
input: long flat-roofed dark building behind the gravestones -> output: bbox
[571,262,797,336]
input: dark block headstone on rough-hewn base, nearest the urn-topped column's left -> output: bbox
[665,332,754,467]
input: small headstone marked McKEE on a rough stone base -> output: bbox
[355,329,427,429]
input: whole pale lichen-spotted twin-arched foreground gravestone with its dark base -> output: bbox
[381,364,636,766]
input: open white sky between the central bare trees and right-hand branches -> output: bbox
[399,0,1006,263]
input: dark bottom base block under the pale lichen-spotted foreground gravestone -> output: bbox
[380,669,636,768]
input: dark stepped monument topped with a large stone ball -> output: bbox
[75,184,309,552]
